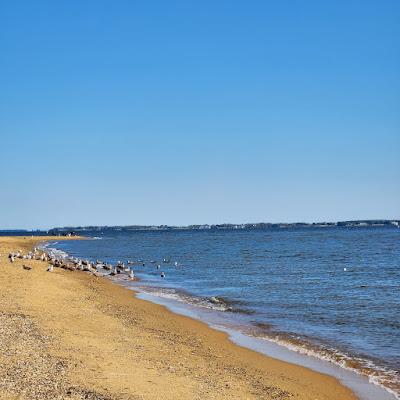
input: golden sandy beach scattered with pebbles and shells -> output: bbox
[0,237,355,400]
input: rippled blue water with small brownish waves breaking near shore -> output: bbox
[50,227,400,391]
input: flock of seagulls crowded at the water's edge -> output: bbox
[8,247,178,280]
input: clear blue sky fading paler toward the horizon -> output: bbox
[0,0,400,229]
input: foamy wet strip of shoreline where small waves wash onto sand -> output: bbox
[122,279,399,400]
